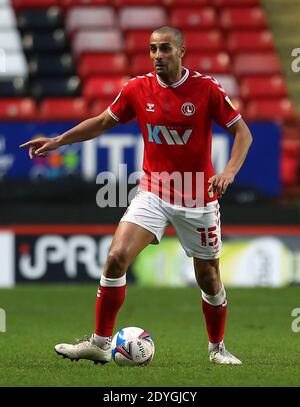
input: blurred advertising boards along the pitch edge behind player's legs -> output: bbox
[0,225,300,287]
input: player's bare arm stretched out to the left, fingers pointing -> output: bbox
[20,110,118,158]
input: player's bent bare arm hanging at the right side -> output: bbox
[208,119,252,197]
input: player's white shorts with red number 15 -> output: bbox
[121,189,222,260]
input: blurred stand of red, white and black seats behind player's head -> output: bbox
[0,0,295,122]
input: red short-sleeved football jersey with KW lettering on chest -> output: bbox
[108,68,241,207]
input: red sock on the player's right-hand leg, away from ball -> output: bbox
[202,299,227,343]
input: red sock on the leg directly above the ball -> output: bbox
[95,285,126,336]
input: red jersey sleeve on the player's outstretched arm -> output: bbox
[107,81,136,123]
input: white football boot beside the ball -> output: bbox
[54,335,111,364]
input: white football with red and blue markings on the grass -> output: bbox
[112,327,155,366]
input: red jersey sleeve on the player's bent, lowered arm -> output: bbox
[211,78,242,128]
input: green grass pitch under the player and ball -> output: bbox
[0,284,300,387]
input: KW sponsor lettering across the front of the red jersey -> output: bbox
[147,123,193,144]
